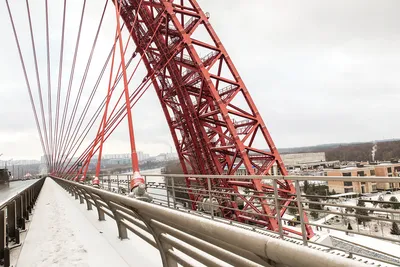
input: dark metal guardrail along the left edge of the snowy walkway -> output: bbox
[0,179,44,267]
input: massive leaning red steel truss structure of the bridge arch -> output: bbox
[118,0,313,237]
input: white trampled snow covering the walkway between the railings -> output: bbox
[17,178,159,267]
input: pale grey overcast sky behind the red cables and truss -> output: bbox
[0,0,400,159]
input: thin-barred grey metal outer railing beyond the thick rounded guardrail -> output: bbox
[90,174,400,265]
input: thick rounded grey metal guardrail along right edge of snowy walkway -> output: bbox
[53,177,365,267]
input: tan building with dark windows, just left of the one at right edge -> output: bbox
[325,167,377,194]
